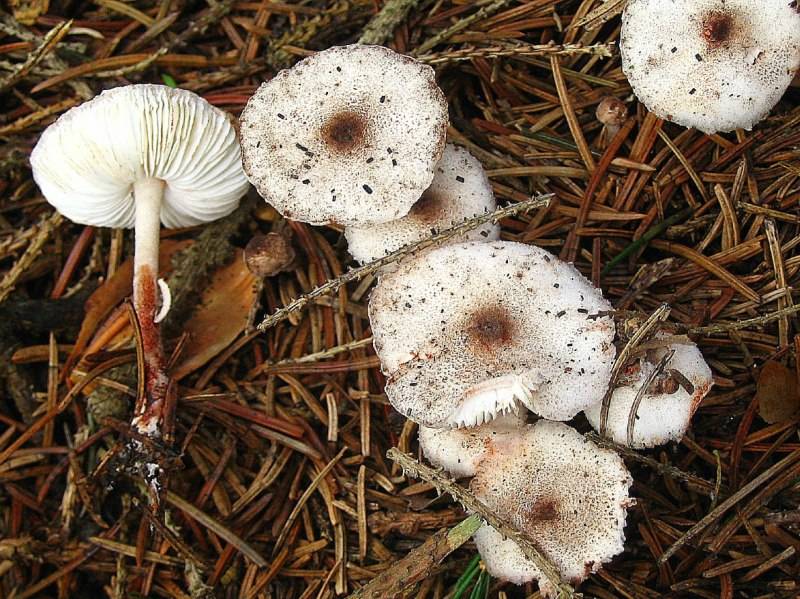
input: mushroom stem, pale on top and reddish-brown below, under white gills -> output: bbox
[133,178,169,437]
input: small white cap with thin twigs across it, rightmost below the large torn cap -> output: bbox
[585,335,713,449]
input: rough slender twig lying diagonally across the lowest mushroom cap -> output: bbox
[386,447,575,597]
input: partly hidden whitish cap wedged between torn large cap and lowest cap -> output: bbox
[419,412,525,478]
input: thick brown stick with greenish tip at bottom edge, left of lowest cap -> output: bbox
[348,514,483,599]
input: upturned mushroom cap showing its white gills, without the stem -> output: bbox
[31,84,249,227]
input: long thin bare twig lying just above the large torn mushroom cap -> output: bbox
[258,195,552,332]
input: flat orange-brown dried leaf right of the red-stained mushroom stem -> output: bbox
[171,250,258,380]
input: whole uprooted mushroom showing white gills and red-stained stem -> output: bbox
[31,85,248,436]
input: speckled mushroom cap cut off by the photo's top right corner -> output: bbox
[620,0,800,133]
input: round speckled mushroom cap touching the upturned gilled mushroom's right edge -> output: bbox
[241,45,448,226]
